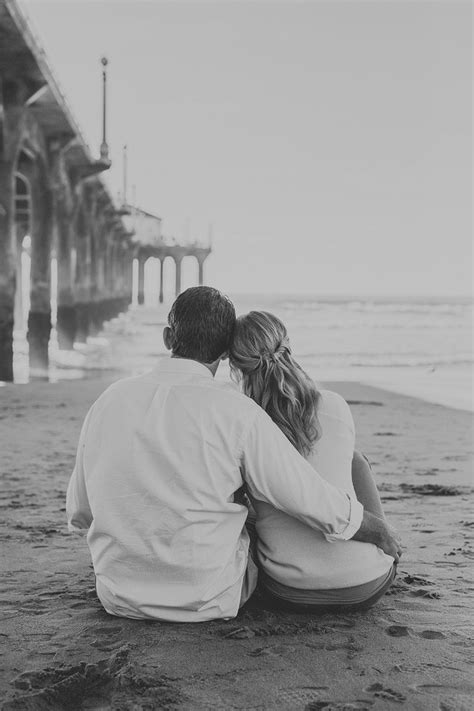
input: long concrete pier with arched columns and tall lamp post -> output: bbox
[0,0,211,381]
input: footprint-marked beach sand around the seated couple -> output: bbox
[0,380,474,711]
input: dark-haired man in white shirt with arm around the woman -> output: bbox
[66,287,398,622]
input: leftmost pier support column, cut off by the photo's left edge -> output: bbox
[0,160,16,382]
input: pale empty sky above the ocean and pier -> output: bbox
[22,0,472,295]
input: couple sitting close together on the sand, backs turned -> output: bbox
[67,287,401,622]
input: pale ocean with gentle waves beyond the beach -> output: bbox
[9,294,474,411]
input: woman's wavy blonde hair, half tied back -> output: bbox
[229,311,320,456]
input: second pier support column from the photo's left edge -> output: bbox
[27,181,53,378]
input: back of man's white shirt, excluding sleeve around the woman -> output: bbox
[67,358,258,621]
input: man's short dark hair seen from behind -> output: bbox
[168,286,235,363]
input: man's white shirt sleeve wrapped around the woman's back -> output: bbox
[241,410,364,541]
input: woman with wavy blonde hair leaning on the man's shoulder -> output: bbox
[230,311,395,611]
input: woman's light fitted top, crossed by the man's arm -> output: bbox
[253,390,393,590]
